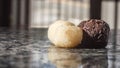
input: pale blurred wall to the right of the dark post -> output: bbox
[101,1,120,29]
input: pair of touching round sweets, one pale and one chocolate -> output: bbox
[48,19,110,48]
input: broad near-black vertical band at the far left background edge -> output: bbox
[0,0,11,27]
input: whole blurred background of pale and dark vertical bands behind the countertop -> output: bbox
[0,0,120,44]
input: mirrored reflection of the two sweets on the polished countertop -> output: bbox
[48,47,108,68]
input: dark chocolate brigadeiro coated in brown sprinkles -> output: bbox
[78,19,110,48]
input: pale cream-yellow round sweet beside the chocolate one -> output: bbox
[48,20,83,48]
